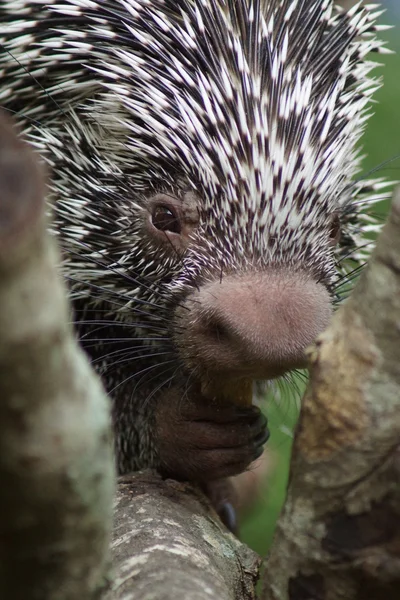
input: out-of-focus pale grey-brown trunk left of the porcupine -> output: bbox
[0,115,114,600]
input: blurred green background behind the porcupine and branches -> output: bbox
[240,9,400,555]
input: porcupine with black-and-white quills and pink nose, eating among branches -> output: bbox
[0,0,390,481]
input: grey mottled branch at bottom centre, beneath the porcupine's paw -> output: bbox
[104,471,259,600]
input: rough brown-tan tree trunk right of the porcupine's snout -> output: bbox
[263,191,400,600]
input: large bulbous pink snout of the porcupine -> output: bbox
[181,270,331,379]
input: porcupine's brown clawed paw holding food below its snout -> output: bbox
[156,390,269,483]
